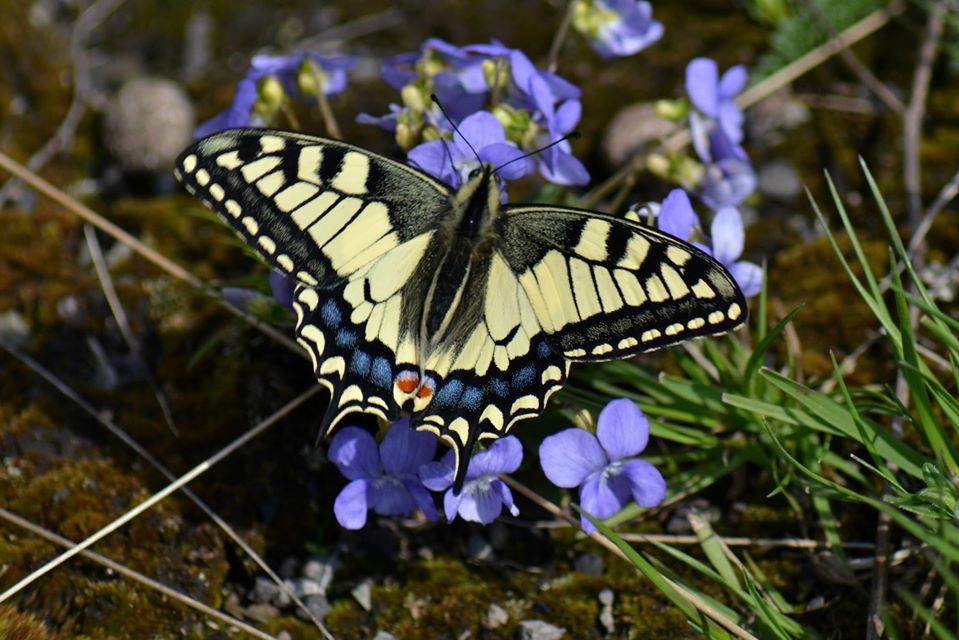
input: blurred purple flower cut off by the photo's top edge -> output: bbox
[573,0,663,58]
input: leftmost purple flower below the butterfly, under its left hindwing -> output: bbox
[329,418,437,529]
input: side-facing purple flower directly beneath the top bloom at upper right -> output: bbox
[689,113,756,210]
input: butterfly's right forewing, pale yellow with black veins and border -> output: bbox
[498,206,747,361]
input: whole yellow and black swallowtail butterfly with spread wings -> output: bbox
[175,129,747,491]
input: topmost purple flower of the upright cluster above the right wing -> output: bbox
[686,58,746,143]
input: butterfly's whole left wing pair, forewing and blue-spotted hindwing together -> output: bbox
[176,129,452,436]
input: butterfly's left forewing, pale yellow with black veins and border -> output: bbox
[176,129,451,287]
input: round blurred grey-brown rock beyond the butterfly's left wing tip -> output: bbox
[104,77,194,171]
